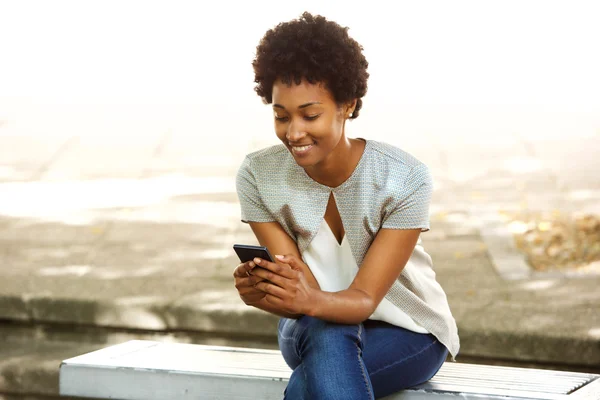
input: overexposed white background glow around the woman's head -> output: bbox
[0,0,600,144]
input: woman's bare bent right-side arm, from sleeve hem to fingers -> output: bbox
[254,229,421,324]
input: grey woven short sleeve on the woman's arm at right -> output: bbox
[382,164,433,232]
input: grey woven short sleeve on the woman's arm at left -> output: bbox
[236,157,275,223]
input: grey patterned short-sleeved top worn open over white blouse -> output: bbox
[237,140,459,358]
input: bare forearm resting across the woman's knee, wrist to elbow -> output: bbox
[307,289,376,324]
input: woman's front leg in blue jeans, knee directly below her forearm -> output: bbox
[278,316,374,400]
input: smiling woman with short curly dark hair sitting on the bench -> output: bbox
[234,13,459,400]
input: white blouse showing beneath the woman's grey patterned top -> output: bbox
[302,219,429,333]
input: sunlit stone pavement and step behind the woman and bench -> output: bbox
[0,126,600,395]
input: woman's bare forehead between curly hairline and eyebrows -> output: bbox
[273,79,334,109]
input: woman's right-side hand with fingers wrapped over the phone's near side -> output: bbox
[253,254,318,315]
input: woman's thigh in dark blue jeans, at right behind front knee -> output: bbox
[363,320,448,397]
